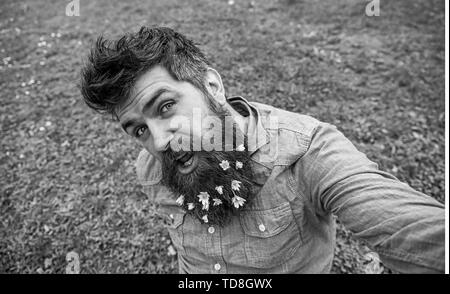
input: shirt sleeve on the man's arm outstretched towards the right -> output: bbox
[294,123,445,273]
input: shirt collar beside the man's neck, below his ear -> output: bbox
[227,96,269,154]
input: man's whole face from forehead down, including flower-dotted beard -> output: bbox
[117,66,253,225]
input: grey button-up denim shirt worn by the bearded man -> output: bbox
[136,97,445,274]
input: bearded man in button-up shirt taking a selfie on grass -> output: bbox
[81,27,445,273]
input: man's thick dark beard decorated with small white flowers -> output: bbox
[162,102,255,227]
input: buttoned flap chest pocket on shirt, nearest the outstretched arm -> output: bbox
[240,202,301,268]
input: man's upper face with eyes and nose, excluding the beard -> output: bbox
[117,66,211,158]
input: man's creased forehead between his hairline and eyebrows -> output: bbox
[116,66,177,119]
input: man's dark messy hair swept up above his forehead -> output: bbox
[80,27,210,118]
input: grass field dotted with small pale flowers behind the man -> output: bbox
[0,0,444,273]
